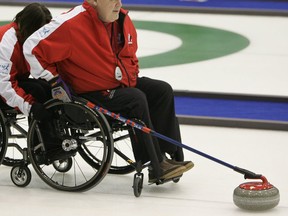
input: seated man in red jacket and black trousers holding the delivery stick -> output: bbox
[24,0,194,183]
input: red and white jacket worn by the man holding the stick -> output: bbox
[24,1,139,94]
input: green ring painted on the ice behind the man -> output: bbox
[134,21,249,68]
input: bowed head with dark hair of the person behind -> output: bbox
[14,3,52,43]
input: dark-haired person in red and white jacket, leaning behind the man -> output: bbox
[0,3,52,120]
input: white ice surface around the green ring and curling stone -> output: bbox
[0,2,288,216]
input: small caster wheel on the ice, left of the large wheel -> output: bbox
[10,165,32,187]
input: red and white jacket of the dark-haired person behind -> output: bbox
[0,22,35,116]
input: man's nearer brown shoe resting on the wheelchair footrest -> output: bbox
[148,159,186,183]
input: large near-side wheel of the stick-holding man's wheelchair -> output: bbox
[28,100,113,191]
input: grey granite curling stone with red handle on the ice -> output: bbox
[233,176,280,211]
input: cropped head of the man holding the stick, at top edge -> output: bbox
[86,0,122,23]
